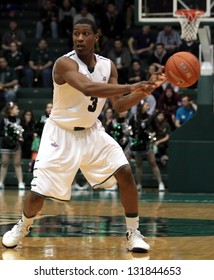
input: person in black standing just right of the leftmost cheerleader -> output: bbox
[21,109,35,159]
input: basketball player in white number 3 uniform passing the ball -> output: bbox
[2,19,166,252]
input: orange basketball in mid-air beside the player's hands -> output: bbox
[165,52,200,87]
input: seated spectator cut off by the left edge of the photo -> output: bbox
[0,56,18,109]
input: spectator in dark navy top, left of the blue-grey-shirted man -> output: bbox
[128,25,155,66]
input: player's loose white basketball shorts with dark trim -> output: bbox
[31,119,129,200]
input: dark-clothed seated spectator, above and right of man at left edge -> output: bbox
[5,42,25,85]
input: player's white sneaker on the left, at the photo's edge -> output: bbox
[2,220,30,248]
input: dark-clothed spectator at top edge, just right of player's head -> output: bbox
[100,1,126,41]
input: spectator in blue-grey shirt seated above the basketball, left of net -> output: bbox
[156,25,182,54]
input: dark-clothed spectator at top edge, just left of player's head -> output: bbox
[59,0,76,38]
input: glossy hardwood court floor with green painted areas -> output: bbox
[0,188,214,260]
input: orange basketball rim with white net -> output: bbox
[176,9,205,42]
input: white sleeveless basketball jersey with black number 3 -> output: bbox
[50,51,111,130]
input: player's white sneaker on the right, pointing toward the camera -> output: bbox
[126,230,150,253]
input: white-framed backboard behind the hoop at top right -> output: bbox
[135,0,214,25]
